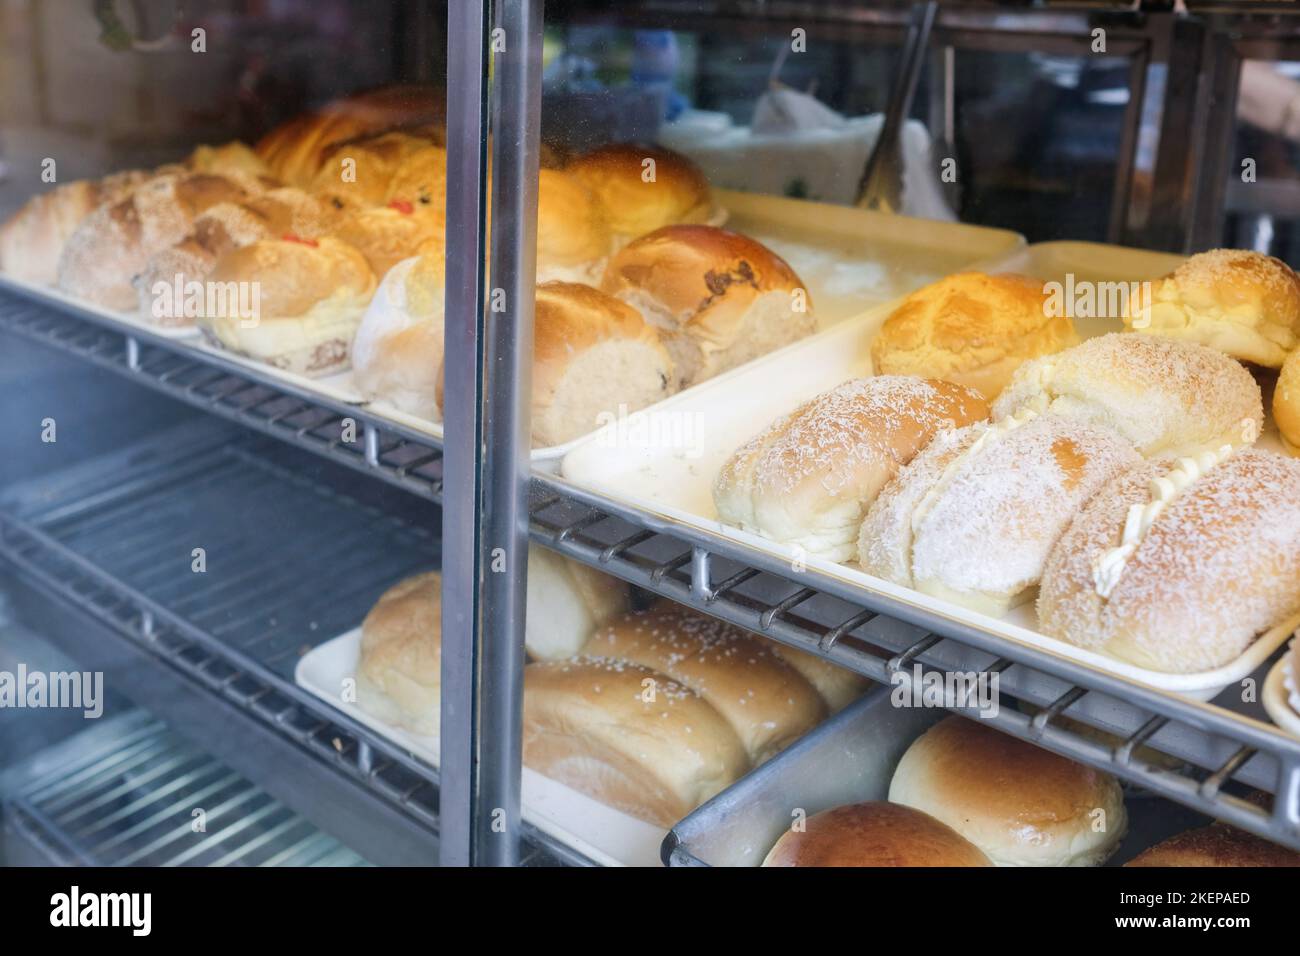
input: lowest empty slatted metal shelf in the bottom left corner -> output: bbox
[0,710,369,866]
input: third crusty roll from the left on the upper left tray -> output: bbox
[133,186,335,326]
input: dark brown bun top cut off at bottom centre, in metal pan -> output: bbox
[763,800,992,866]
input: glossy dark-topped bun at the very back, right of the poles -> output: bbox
[564,143,716,238]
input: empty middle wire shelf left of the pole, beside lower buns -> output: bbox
[0,418,585,864]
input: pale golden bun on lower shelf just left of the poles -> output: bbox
[356,571,442,736]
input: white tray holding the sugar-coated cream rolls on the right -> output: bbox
[562,242,1295,700]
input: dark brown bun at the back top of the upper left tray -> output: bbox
[256,85,446,189]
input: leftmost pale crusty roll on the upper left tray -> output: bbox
[0,170,148,285]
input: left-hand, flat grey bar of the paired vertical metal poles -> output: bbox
[438,0,488,866]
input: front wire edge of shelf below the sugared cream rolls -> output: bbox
[529,476,1300,848]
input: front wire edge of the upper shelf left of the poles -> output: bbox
[0,287,442,501]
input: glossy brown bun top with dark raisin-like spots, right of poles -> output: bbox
[601,225,811,325]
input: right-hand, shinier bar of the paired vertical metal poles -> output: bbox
[477,0,542,866]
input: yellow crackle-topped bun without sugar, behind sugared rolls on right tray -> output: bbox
[871,272,1079,402]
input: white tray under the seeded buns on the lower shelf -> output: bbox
[294,628,666,866]
